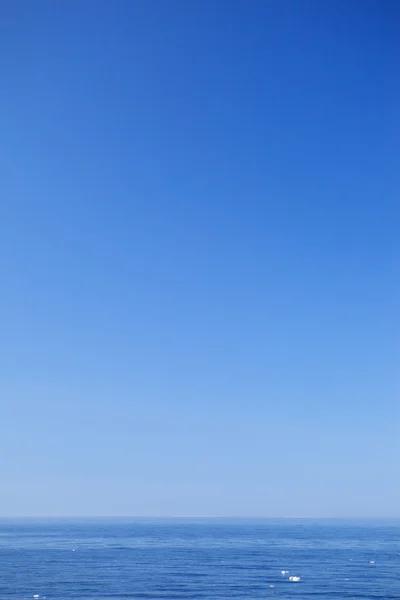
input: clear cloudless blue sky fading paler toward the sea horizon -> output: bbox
[0,0,400,516]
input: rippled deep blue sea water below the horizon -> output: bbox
[0,519,400,600]
